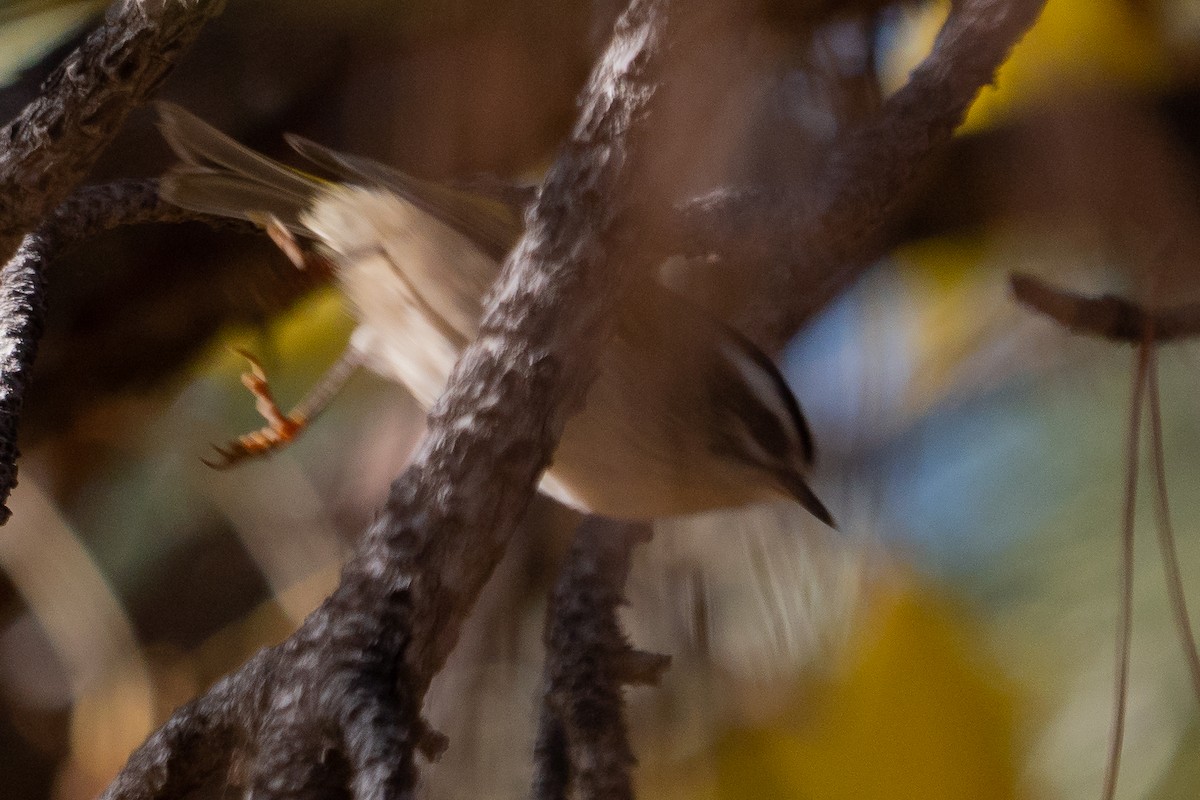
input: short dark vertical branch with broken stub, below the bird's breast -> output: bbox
[533,518,671,800]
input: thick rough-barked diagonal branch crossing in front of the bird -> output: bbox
[103,0,666,800]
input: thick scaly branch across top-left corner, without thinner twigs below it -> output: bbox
[0,0,224,250]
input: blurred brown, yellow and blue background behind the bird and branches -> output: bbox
[0,0,1200,800]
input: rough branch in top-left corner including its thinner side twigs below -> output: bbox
[0,0,224,524]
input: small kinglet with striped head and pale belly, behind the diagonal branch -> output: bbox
[160,104,833,525]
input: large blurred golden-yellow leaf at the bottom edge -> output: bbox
[716,583,1016,800]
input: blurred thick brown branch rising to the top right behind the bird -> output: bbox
[674,0,1044,350]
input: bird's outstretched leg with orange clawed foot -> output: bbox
[202,344,362,469]
